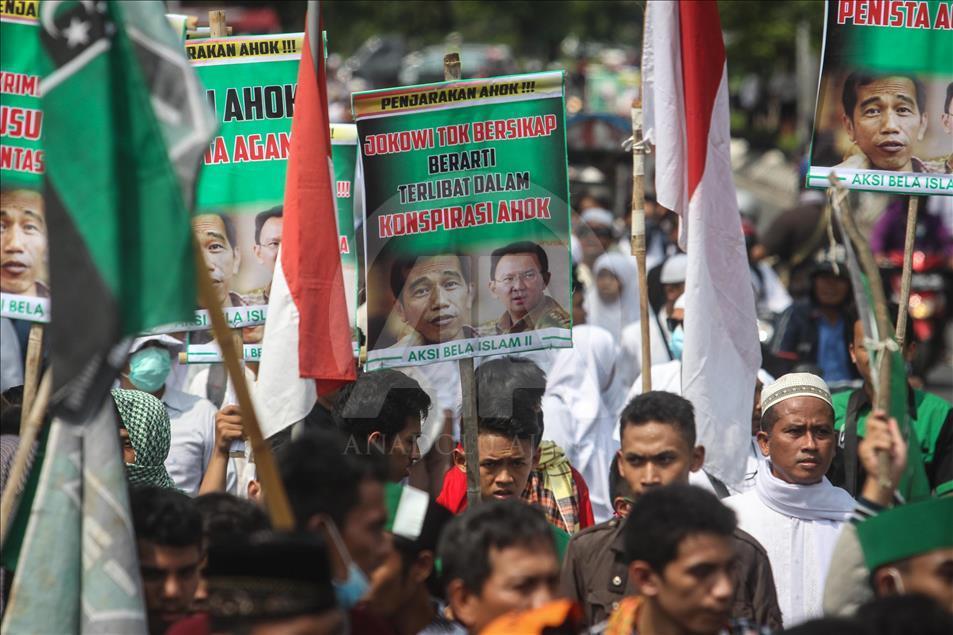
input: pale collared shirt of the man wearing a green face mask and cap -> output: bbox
[162,387,237,496]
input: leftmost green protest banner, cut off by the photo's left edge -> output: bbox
[0,0,50,322]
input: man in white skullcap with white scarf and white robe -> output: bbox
[725,373,854,627]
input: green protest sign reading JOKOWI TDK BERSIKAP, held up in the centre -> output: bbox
[352,72,572,369]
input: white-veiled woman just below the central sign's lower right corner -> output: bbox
[542,324,625,522]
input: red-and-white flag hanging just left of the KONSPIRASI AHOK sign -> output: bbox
[255,1,355,437]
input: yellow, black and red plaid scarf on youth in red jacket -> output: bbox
[523,441,579,535]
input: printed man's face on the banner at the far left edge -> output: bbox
[0,190,50,298]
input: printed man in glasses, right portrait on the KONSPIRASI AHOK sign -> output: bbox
[484,240,571,335]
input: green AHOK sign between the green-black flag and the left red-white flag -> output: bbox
[185,33,302,343]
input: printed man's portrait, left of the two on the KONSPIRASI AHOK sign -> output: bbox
[390,254,476,348]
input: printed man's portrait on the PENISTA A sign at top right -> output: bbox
[834,72,930,172]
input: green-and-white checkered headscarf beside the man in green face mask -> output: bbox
[112,388,175,489]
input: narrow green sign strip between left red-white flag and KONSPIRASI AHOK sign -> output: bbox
[331,123,360,357]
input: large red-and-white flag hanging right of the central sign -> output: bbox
[642,1,761,485]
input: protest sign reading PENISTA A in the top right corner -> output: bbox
[807,0,953,195]
